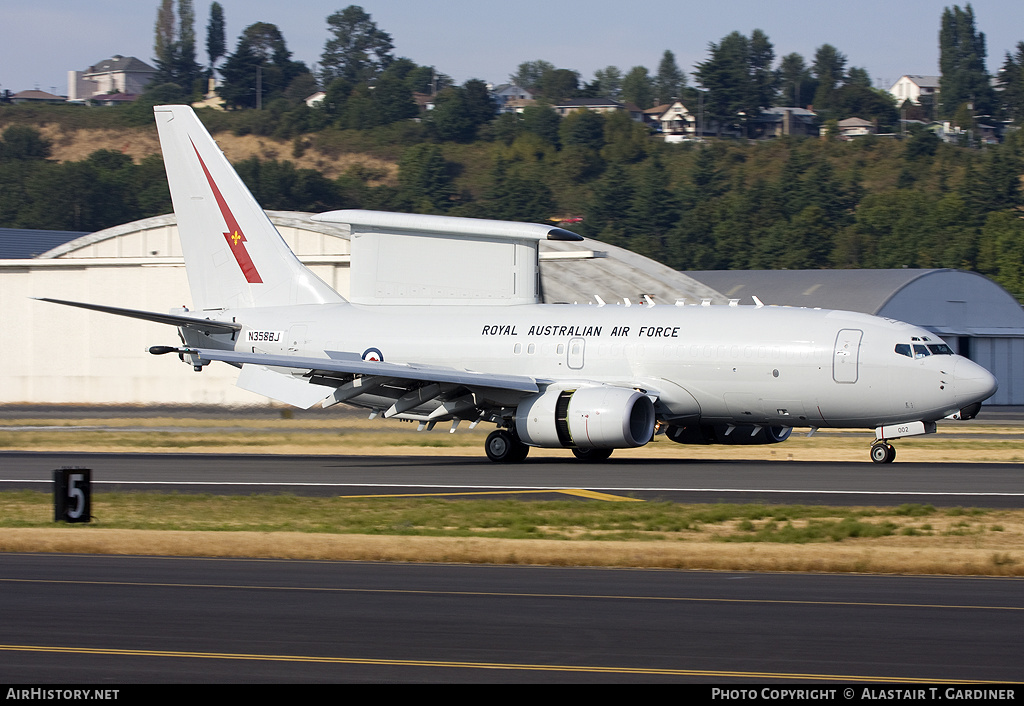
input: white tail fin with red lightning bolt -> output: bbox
[154,106,344,309]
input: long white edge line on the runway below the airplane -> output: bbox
[6,479,1024,498]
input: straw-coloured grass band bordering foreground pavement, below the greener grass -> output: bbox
[0,528,1024,576]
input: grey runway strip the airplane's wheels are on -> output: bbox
[0,452,1024,508]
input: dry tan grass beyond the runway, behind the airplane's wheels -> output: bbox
[0,416,1024,463]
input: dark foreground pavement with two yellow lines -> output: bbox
[0,554,1024,684]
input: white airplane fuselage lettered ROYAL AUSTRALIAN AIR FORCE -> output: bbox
[206,303,995,427]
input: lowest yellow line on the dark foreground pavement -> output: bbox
[0,645,1007,683]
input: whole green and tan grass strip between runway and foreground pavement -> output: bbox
[6,492,1024,576]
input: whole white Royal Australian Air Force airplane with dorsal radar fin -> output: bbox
[37,106,996,463]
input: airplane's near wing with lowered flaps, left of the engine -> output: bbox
[150,346,548,423]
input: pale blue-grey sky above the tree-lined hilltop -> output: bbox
[0,0,1024,95]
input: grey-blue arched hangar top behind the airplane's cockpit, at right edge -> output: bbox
[686,269,1024,336]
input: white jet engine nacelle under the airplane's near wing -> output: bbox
[515,386,655,450]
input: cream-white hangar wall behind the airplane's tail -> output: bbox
[0,212,348,405]
